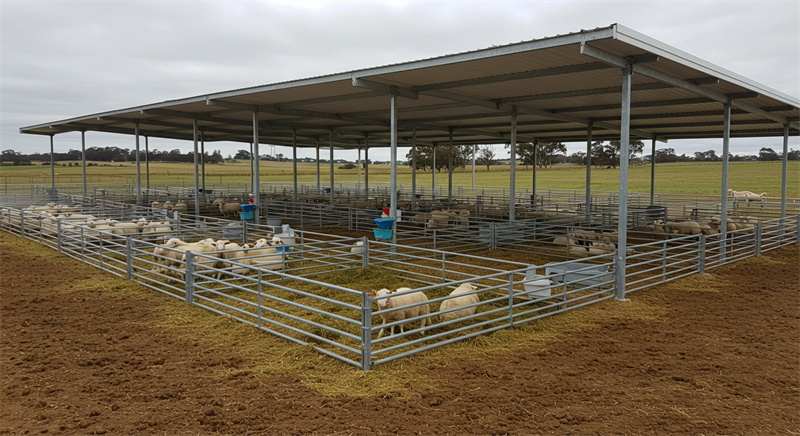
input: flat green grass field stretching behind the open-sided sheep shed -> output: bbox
[0,161,800,198]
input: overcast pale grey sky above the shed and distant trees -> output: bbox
[0,0,800,160]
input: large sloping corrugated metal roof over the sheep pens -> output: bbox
[20,24,800,148]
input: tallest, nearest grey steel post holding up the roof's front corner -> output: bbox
[614,59,633,300]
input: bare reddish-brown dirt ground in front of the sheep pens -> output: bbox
[0,233,800,435]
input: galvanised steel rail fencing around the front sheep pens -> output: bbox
[0,194,800,370]
